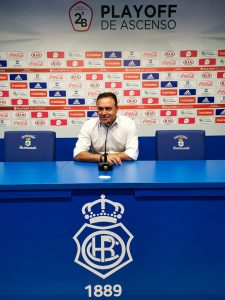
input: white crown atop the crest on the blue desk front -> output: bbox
[82,195,124,224]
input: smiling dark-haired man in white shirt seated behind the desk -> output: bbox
[73,92,138,165]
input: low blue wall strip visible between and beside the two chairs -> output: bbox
[0,136,225,161]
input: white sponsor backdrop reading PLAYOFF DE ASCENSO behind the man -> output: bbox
[0,0,225,138]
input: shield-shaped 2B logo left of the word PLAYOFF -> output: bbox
[69,1,93,32]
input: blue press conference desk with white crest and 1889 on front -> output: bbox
[0,161,225,300]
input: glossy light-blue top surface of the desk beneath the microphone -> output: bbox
[0,160,225,190]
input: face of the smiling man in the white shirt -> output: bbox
[96,97,117,125]
